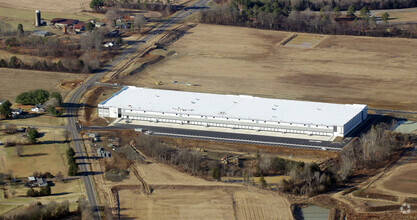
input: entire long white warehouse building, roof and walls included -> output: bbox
[98,86,367,136]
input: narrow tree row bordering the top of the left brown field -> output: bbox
[0,56,94,73]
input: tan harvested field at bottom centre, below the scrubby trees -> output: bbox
[114,157,292,219]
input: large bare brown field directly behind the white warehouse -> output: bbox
[115,24,417,110]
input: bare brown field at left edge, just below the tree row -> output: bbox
[0,68,87,103]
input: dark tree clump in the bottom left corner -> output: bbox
[0,200,71,220]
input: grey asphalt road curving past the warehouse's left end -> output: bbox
[66,0,209,219]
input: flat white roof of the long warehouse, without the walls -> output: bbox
[99,86,366,126]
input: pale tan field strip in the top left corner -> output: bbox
[0,0,90,13]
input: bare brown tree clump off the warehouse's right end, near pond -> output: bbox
[340,123,409,180]
